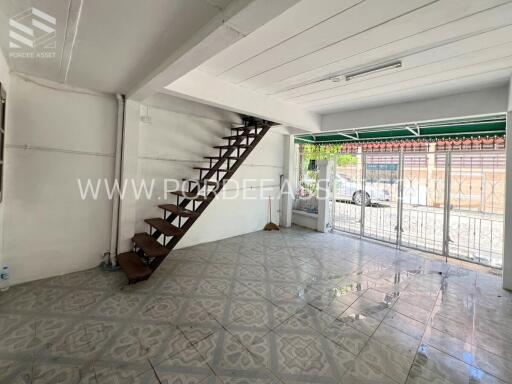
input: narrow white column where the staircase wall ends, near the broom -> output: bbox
[280,135,296,227]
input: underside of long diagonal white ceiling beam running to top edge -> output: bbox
[127,0,299,101]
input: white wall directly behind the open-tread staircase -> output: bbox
[135,95,284,247]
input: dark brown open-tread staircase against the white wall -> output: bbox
[117,118,271,284]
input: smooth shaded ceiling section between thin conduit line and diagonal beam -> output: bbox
[67,0,219,93]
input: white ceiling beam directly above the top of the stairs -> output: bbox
[163,69,322,132]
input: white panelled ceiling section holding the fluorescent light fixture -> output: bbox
[198,0,512,113]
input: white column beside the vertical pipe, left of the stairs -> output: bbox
[118,100,140,253]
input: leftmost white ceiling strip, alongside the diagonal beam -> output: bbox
[202,0,363,76]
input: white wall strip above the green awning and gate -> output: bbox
[322,86,508,131]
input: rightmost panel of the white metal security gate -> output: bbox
[448,151,505,267]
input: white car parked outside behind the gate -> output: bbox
[335,173,391,205]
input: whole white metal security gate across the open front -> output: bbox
[333,144,505,268]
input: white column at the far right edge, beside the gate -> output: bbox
[503,78,512,290]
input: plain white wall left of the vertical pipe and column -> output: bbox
[4,75,117,284]
